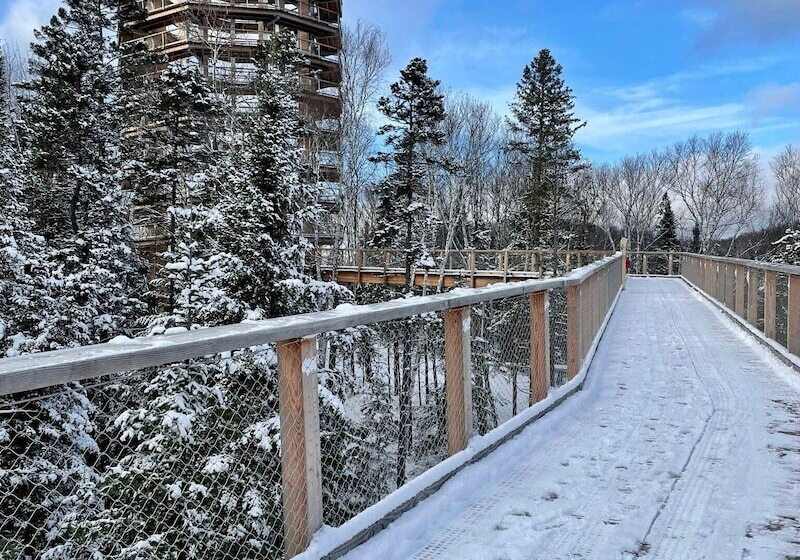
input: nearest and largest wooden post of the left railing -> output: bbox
[278,338,322,558]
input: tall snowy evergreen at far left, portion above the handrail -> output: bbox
[22,0,143,350]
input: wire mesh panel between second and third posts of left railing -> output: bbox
[472,296,531,434]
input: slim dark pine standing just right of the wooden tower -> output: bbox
[372,58,445,291]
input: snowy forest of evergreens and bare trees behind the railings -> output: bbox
[0,0,800,560]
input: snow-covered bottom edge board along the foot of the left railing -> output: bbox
[294,284,624,560]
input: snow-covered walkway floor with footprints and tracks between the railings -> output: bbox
[346,278,800,560]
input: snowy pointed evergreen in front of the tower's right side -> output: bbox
[221,32,339,318]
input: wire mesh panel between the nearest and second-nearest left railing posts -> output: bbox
[319,313,446,526]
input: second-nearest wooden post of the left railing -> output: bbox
[444,307,472,455]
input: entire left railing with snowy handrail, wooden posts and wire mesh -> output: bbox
[0,254,624,559]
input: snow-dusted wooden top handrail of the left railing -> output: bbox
[0,255,621,396]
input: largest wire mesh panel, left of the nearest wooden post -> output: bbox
[0,348,292,560]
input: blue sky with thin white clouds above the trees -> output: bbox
[0,0,800,165]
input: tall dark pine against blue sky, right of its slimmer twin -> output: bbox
[508,49,585,258]
